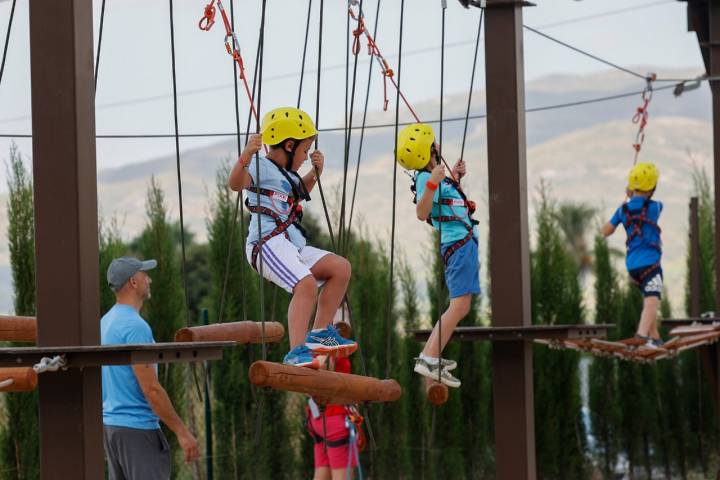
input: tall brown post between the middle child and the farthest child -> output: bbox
[485,0,535,479]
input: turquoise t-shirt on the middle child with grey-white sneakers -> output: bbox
[415,172,479,245]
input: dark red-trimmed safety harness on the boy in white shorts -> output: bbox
[245,160,310,270]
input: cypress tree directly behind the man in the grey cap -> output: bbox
[139,177,189,478]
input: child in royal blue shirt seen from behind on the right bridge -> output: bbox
[602,163,663,348]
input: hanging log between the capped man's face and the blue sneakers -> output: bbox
[175,322,285,343]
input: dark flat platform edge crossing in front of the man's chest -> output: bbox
[0,342,236,368]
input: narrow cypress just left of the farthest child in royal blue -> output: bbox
[589,236,620,478]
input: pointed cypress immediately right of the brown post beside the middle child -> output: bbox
[531,191,587,479]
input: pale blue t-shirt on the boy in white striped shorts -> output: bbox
[246,157,306,248]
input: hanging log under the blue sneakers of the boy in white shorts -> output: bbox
[250,361,402,404]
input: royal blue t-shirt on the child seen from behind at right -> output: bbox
[610,196,662,270]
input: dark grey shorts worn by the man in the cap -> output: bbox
[103,425,170,480]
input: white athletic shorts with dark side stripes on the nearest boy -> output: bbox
[245,234,330,293]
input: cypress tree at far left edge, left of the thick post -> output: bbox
[0,143,40,480]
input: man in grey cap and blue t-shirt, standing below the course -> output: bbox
[100,257,199,480]
